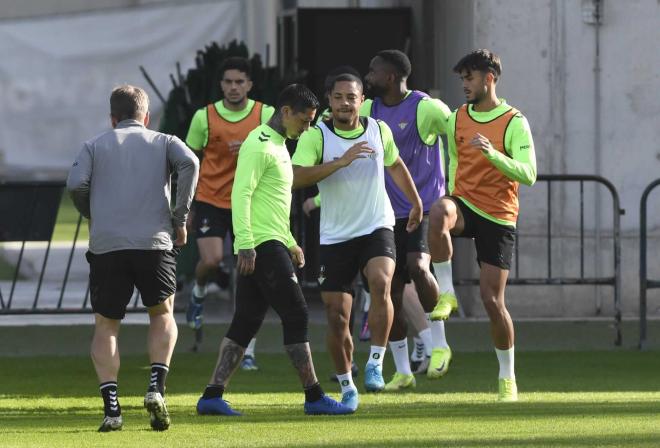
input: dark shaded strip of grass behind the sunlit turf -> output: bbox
[0,351,660,402]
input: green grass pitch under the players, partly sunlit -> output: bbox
[0,324,660,447]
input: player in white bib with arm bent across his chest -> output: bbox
[292,74,422,409]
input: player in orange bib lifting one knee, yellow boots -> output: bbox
[429,50,536,401]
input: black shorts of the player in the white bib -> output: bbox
[318,229,396,294]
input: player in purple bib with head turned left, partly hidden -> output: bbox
[361,50,451,391]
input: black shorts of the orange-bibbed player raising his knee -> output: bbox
[451,196,516,271]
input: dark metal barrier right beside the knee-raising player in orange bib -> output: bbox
[456,174,625,345]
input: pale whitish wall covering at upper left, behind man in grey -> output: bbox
[0,0,277,178]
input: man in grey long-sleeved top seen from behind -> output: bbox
[67,85,199,432]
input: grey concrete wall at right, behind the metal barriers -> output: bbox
[434,0,660,315]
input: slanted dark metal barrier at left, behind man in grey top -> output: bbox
[0,181,144,315]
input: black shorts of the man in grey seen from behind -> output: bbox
[85,249,179,320]
